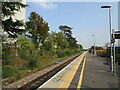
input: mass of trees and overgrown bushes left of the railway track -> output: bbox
[2,2,82,82]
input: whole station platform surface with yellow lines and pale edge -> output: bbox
[37,51,118,90]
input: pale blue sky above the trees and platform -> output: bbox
[26,2,118,49]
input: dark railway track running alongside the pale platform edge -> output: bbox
[17,52,82,90]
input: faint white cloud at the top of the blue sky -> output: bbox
[38,2,58,9]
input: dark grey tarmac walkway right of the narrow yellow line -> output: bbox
[81,53,120,90]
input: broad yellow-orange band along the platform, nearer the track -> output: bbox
[58,53,86,88]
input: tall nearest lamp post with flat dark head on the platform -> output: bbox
[101,5,113,71]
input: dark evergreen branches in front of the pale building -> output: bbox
[1,2,27,38]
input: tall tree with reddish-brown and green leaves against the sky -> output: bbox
[26,12,49,48]
